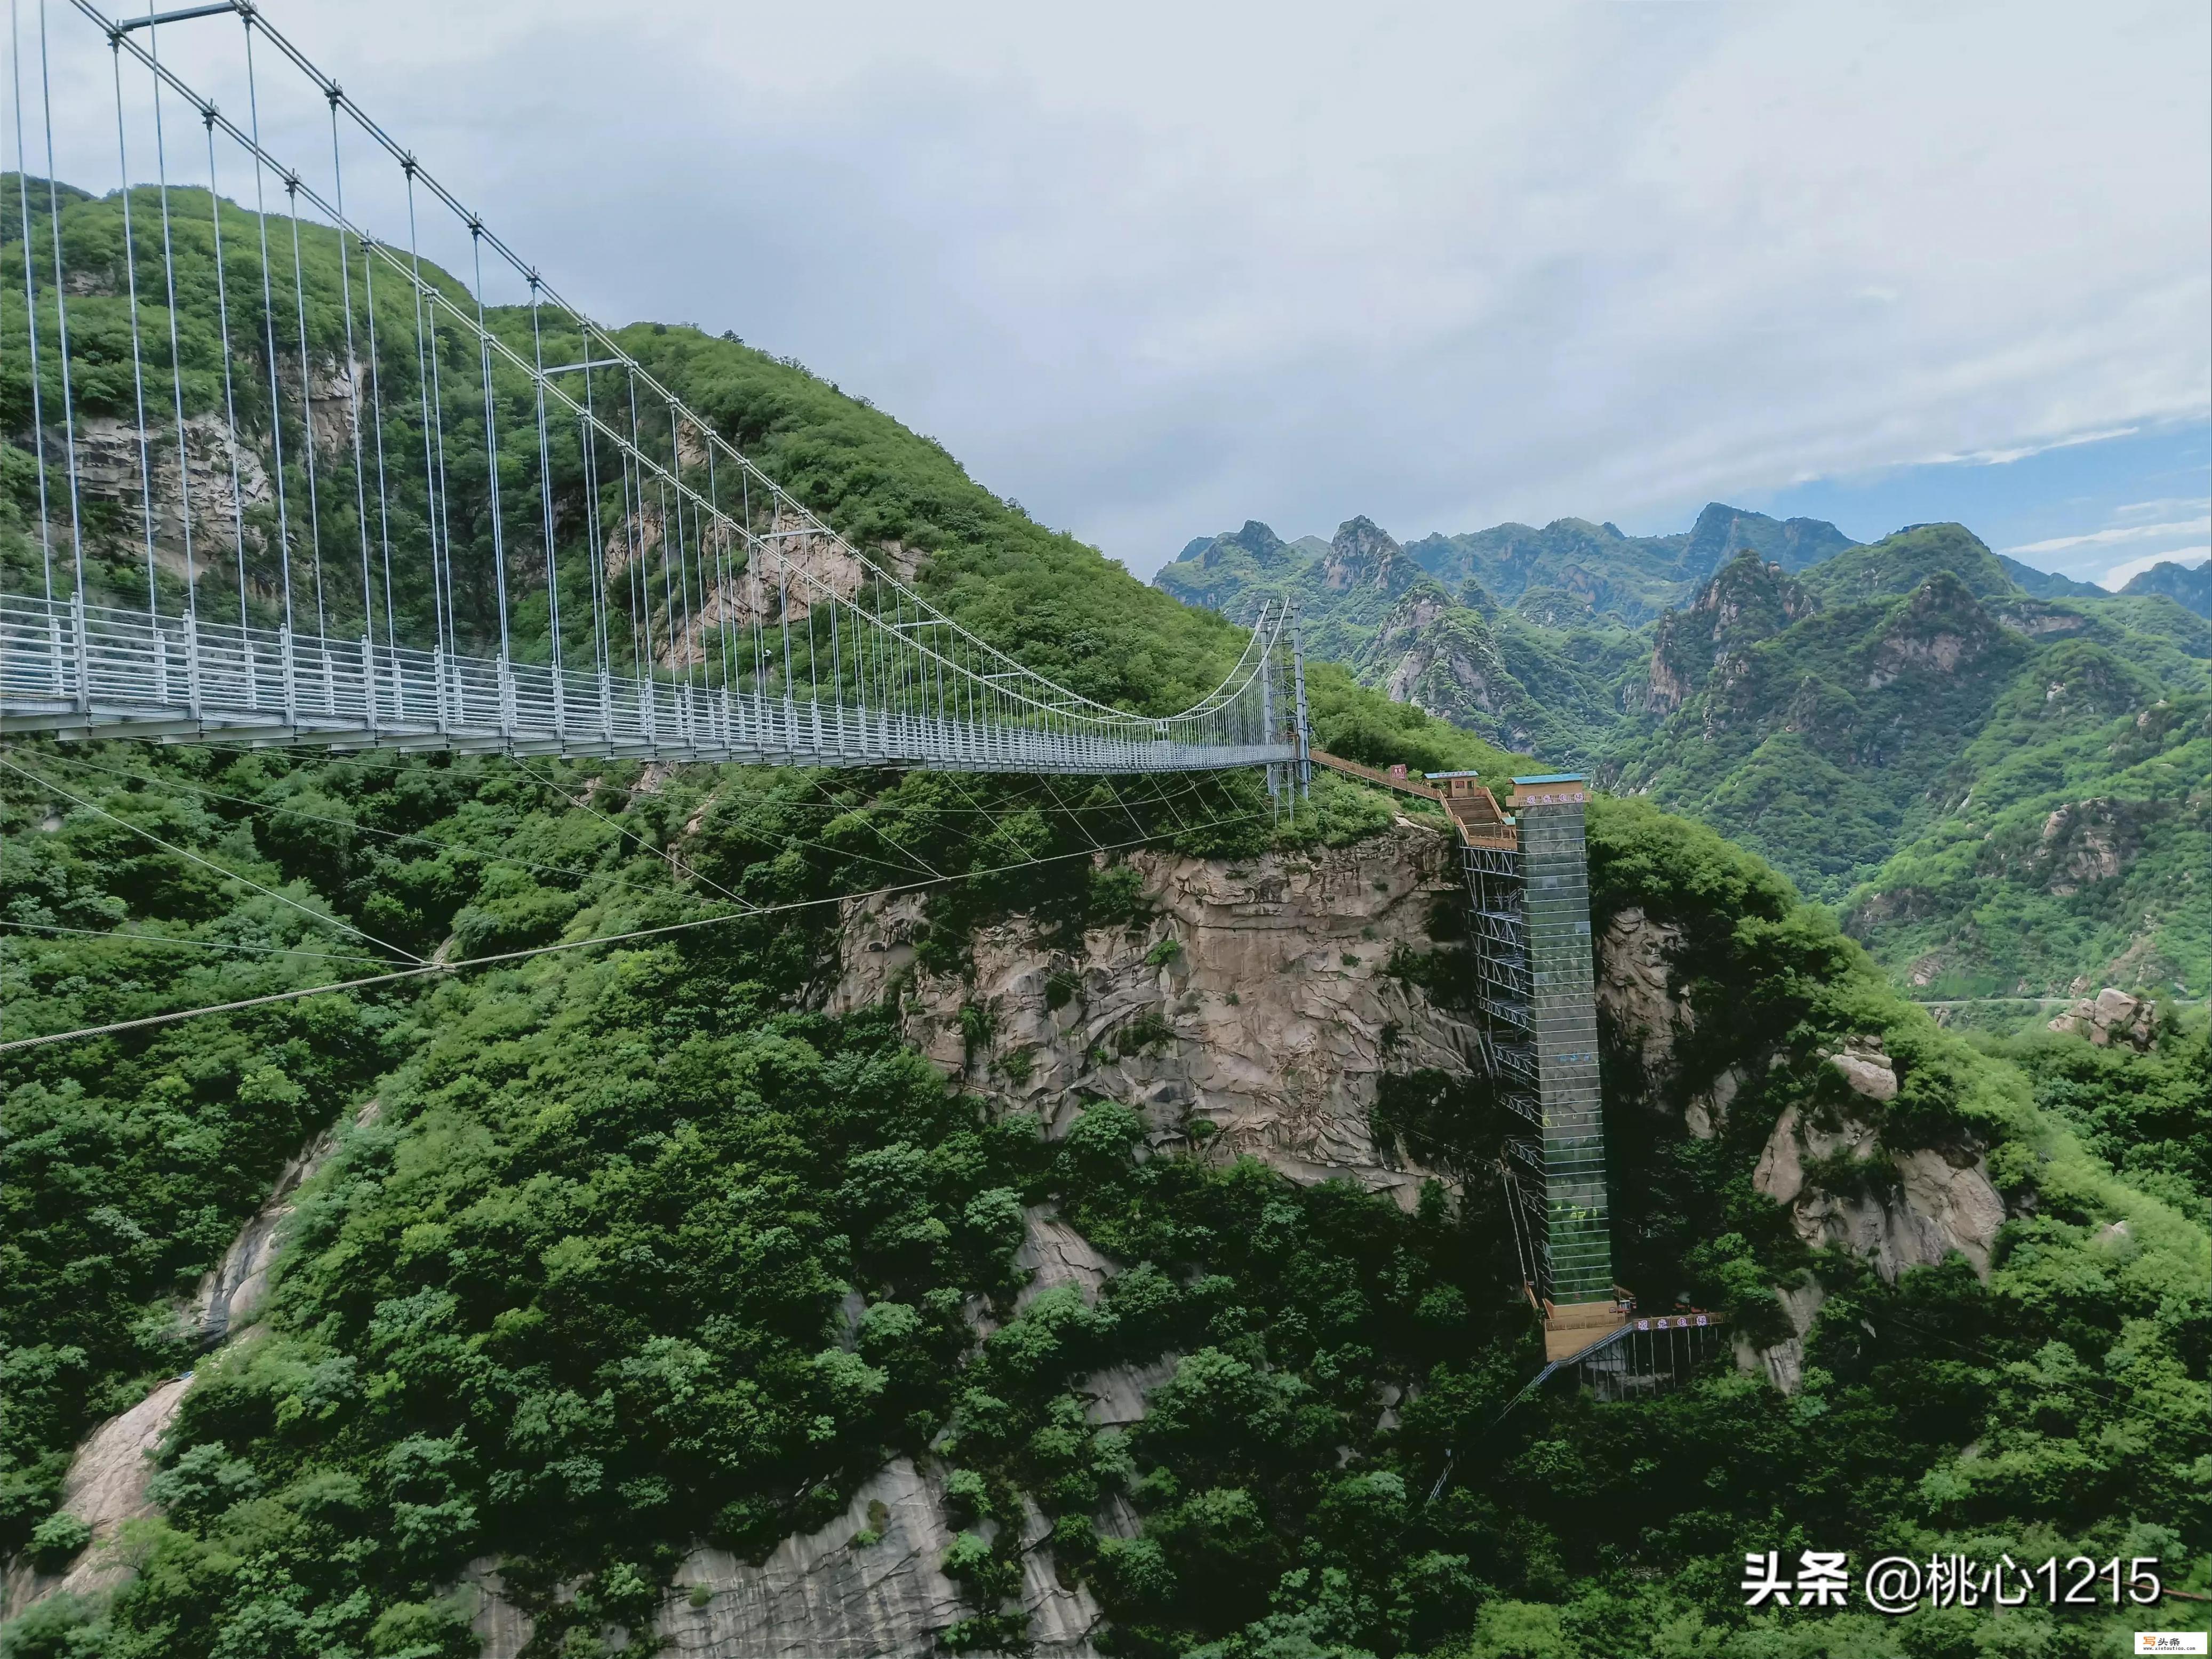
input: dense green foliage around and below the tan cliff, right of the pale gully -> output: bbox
[18,776,2212,1659]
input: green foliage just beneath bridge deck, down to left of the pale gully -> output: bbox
[0,745,1327,1546]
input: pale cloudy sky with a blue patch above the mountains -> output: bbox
[34,0,2212,582]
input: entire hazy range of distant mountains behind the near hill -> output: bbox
[1157,502,2212,995]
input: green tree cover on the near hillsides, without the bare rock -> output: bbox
[0,181,2212,1659]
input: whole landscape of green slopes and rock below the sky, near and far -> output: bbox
[0,179,2212,1659]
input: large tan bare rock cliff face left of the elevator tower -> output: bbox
[829,823,1475,1203]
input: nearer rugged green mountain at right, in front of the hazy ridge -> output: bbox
[1612,535,2212,995]
